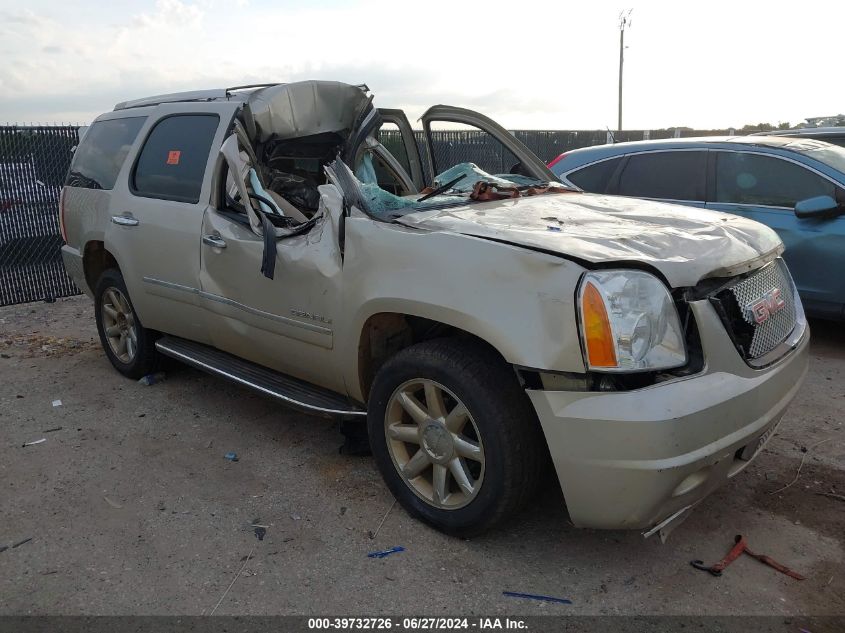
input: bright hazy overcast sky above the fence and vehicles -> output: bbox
[0,0,845,129]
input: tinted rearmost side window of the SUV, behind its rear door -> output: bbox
[65,117,146,189]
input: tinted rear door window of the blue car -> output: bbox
[619,152,707,202]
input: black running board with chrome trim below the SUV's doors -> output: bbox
[156,336,367,417]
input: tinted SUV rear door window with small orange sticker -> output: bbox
[132,114,220,202]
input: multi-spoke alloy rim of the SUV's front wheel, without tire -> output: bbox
[384,378,485,510]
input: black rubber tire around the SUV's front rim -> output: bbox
[367,338,548,537]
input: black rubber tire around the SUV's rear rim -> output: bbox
[94,268,160,379]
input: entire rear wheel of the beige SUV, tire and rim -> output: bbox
[94,269,158,378]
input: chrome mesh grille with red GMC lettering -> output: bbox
[730,258,796,359]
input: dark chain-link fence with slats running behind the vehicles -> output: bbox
[0,126,733,305]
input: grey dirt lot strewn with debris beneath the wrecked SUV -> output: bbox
[0,297,845,615]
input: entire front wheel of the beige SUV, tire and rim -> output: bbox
[367,338,545,536]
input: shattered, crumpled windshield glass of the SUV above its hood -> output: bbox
[355,156,558,220]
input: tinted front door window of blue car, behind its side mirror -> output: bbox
[715,152,836,208]
